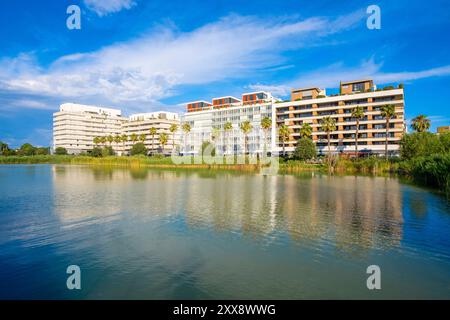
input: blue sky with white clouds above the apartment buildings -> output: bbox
[0,0,450,147]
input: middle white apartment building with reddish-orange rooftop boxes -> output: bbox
[182,91,278,154]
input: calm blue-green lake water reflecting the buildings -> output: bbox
[0,165,450,299]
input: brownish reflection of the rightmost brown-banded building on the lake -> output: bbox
[277,176,403,250]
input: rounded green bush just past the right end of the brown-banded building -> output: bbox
[400,132,442,160]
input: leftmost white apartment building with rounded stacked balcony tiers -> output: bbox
[53,103,126,154]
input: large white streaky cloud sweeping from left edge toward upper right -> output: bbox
[0,12,362,113]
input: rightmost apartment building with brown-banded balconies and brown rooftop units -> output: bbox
[272,80,406,153]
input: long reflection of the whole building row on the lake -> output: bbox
[53,166,403,253]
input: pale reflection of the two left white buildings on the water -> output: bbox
[53,166,182,226]
